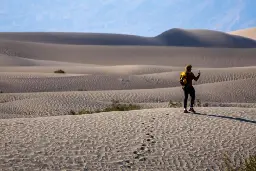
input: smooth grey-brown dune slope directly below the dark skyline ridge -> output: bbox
[0,41,256,68]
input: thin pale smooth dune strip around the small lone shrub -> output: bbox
[0,64,175,76]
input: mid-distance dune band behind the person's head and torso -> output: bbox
[0,66,256,93]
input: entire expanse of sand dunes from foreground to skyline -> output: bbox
[0,29,256,171]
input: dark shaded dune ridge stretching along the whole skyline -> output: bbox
[0,28,256,48]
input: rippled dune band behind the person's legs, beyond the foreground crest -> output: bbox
[0,78,256,117]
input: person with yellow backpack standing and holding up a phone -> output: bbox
[180,65,201,113]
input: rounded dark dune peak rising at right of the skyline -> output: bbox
[156,29,256,48]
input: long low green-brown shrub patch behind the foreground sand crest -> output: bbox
[69,100,141,115]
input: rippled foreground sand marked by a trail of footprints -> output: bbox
[0,108,256,171]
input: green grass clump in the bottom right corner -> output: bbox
[224,155,256,171]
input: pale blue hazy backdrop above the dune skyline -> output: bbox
[0,0,256,36]
